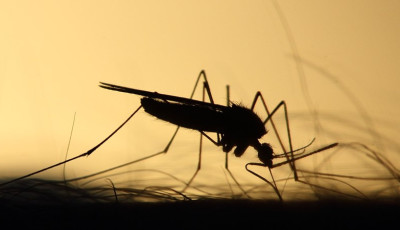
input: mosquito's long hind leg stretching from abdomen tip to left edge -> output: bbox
[0,106,142,187]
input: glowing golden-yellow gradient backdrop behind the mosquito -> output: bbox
[0,0,400,199]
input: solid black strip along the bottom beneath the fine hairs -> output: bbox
[0,200,400,229]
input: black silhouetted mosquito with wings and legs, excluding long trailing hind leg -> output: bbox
[99,70,337,200]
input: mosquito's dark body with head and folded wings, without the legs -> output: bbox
[100,76,273,167]
